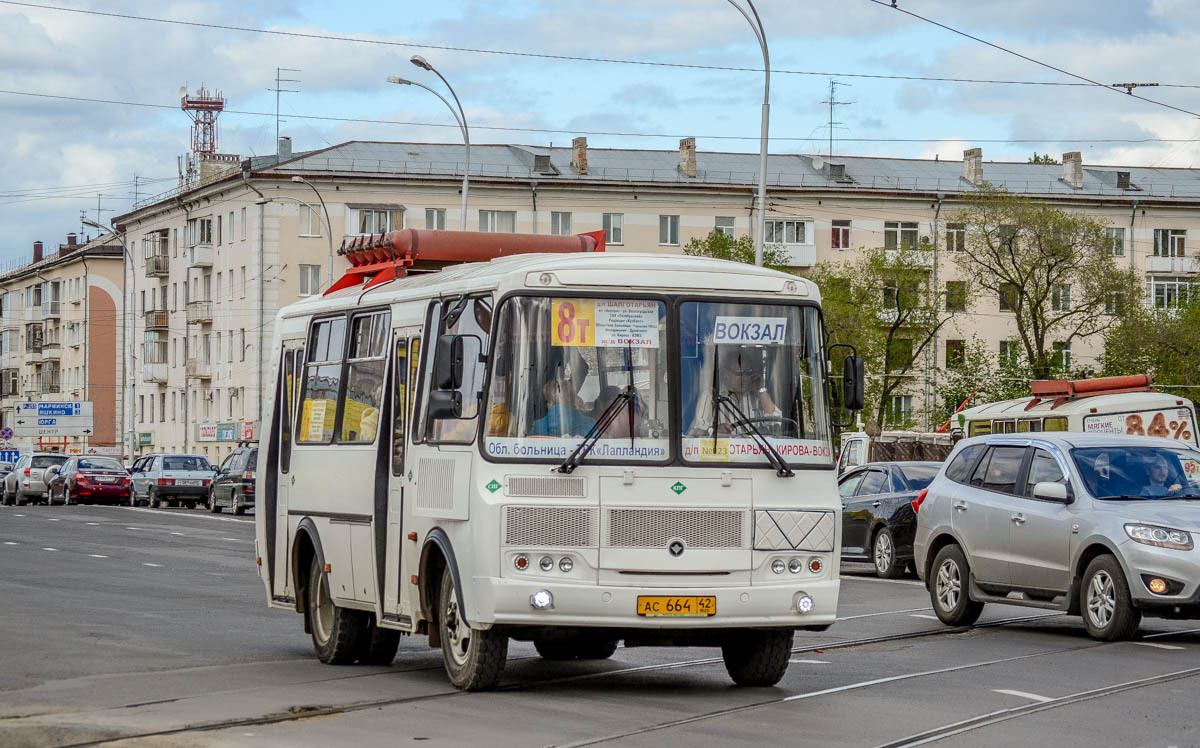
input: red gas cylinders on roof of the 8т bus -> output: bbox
[322,228,605,295]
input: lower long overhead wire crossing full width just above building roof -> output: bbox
[0,86,1194,144]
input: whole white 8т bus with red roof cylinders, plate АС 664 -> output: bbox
[256,229,862,689]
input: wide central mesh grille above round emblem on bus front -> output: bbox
[605,509,746,547]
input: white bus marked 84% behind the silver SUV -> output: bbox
[953,375,1200,447]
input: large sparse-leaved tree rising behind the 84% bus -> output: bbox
[952,185,1140,379]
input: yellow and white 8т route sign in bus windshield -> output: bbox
[551,299,661,348]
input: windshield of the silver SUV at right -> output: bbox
[1072,445,1200,499]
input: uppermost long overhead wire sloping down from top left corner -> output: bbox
[7,0,1200,92]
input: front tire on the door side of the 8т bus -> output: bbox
[438,567,509,690]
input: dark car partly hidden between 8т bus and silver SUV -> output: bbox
[838,462,942,579]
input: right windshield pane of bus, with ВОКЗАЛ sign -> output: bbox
[679,301,833,466]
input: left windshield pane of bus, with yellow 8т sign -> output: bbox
[484,297,671,462]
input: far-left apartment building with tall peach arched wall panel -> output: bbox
[0,234,125,453]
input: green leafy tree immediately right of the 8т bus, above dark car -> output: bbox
[809,246,954,426]
